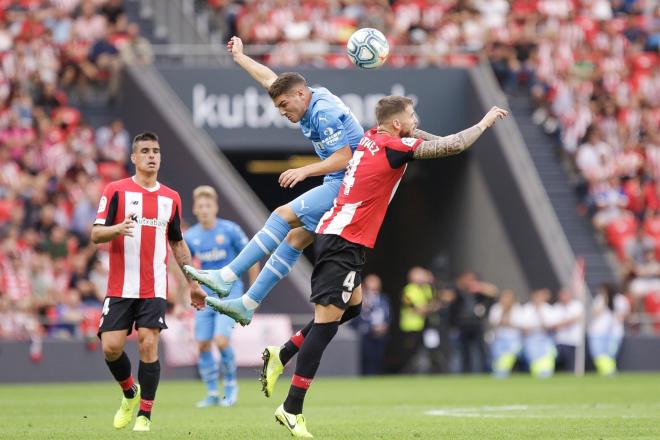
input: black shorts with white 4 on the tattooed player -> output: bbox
[310,234,366,310]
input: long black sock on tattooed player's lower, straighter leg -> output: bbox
[284,321,339,414]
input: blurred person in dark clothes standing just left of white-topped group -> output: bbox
[450,271,498,373]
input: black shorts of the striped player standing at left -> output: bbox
[98,296,167,338]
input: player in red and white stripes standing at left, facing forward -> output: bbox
[91,132,206,431]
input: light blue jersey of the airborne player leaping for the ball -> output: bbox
[300,87,364,182]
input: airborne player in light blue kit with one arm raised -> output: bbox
[184,37,364,325]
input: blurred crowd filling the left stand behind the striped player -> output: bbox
[0,0,150,354]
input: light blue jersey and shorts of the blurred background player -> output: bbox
[183,219,248,341]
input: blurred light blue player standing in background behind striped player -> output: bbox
[183,185,259,408]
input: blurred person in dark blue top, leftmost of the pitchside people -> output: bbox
[352,274,390,376]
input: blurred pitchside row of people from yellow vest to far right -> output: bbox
[386,267,630,377]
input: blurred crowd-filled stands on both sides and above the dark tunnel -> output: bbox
[0,0,660,354]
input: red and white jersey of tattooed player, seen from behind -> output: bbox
[316,128,422,248]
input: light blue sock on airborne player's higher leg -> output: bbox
[229,212,291,277]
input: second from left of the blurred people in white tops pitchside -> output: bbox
[521,289,557,378]
